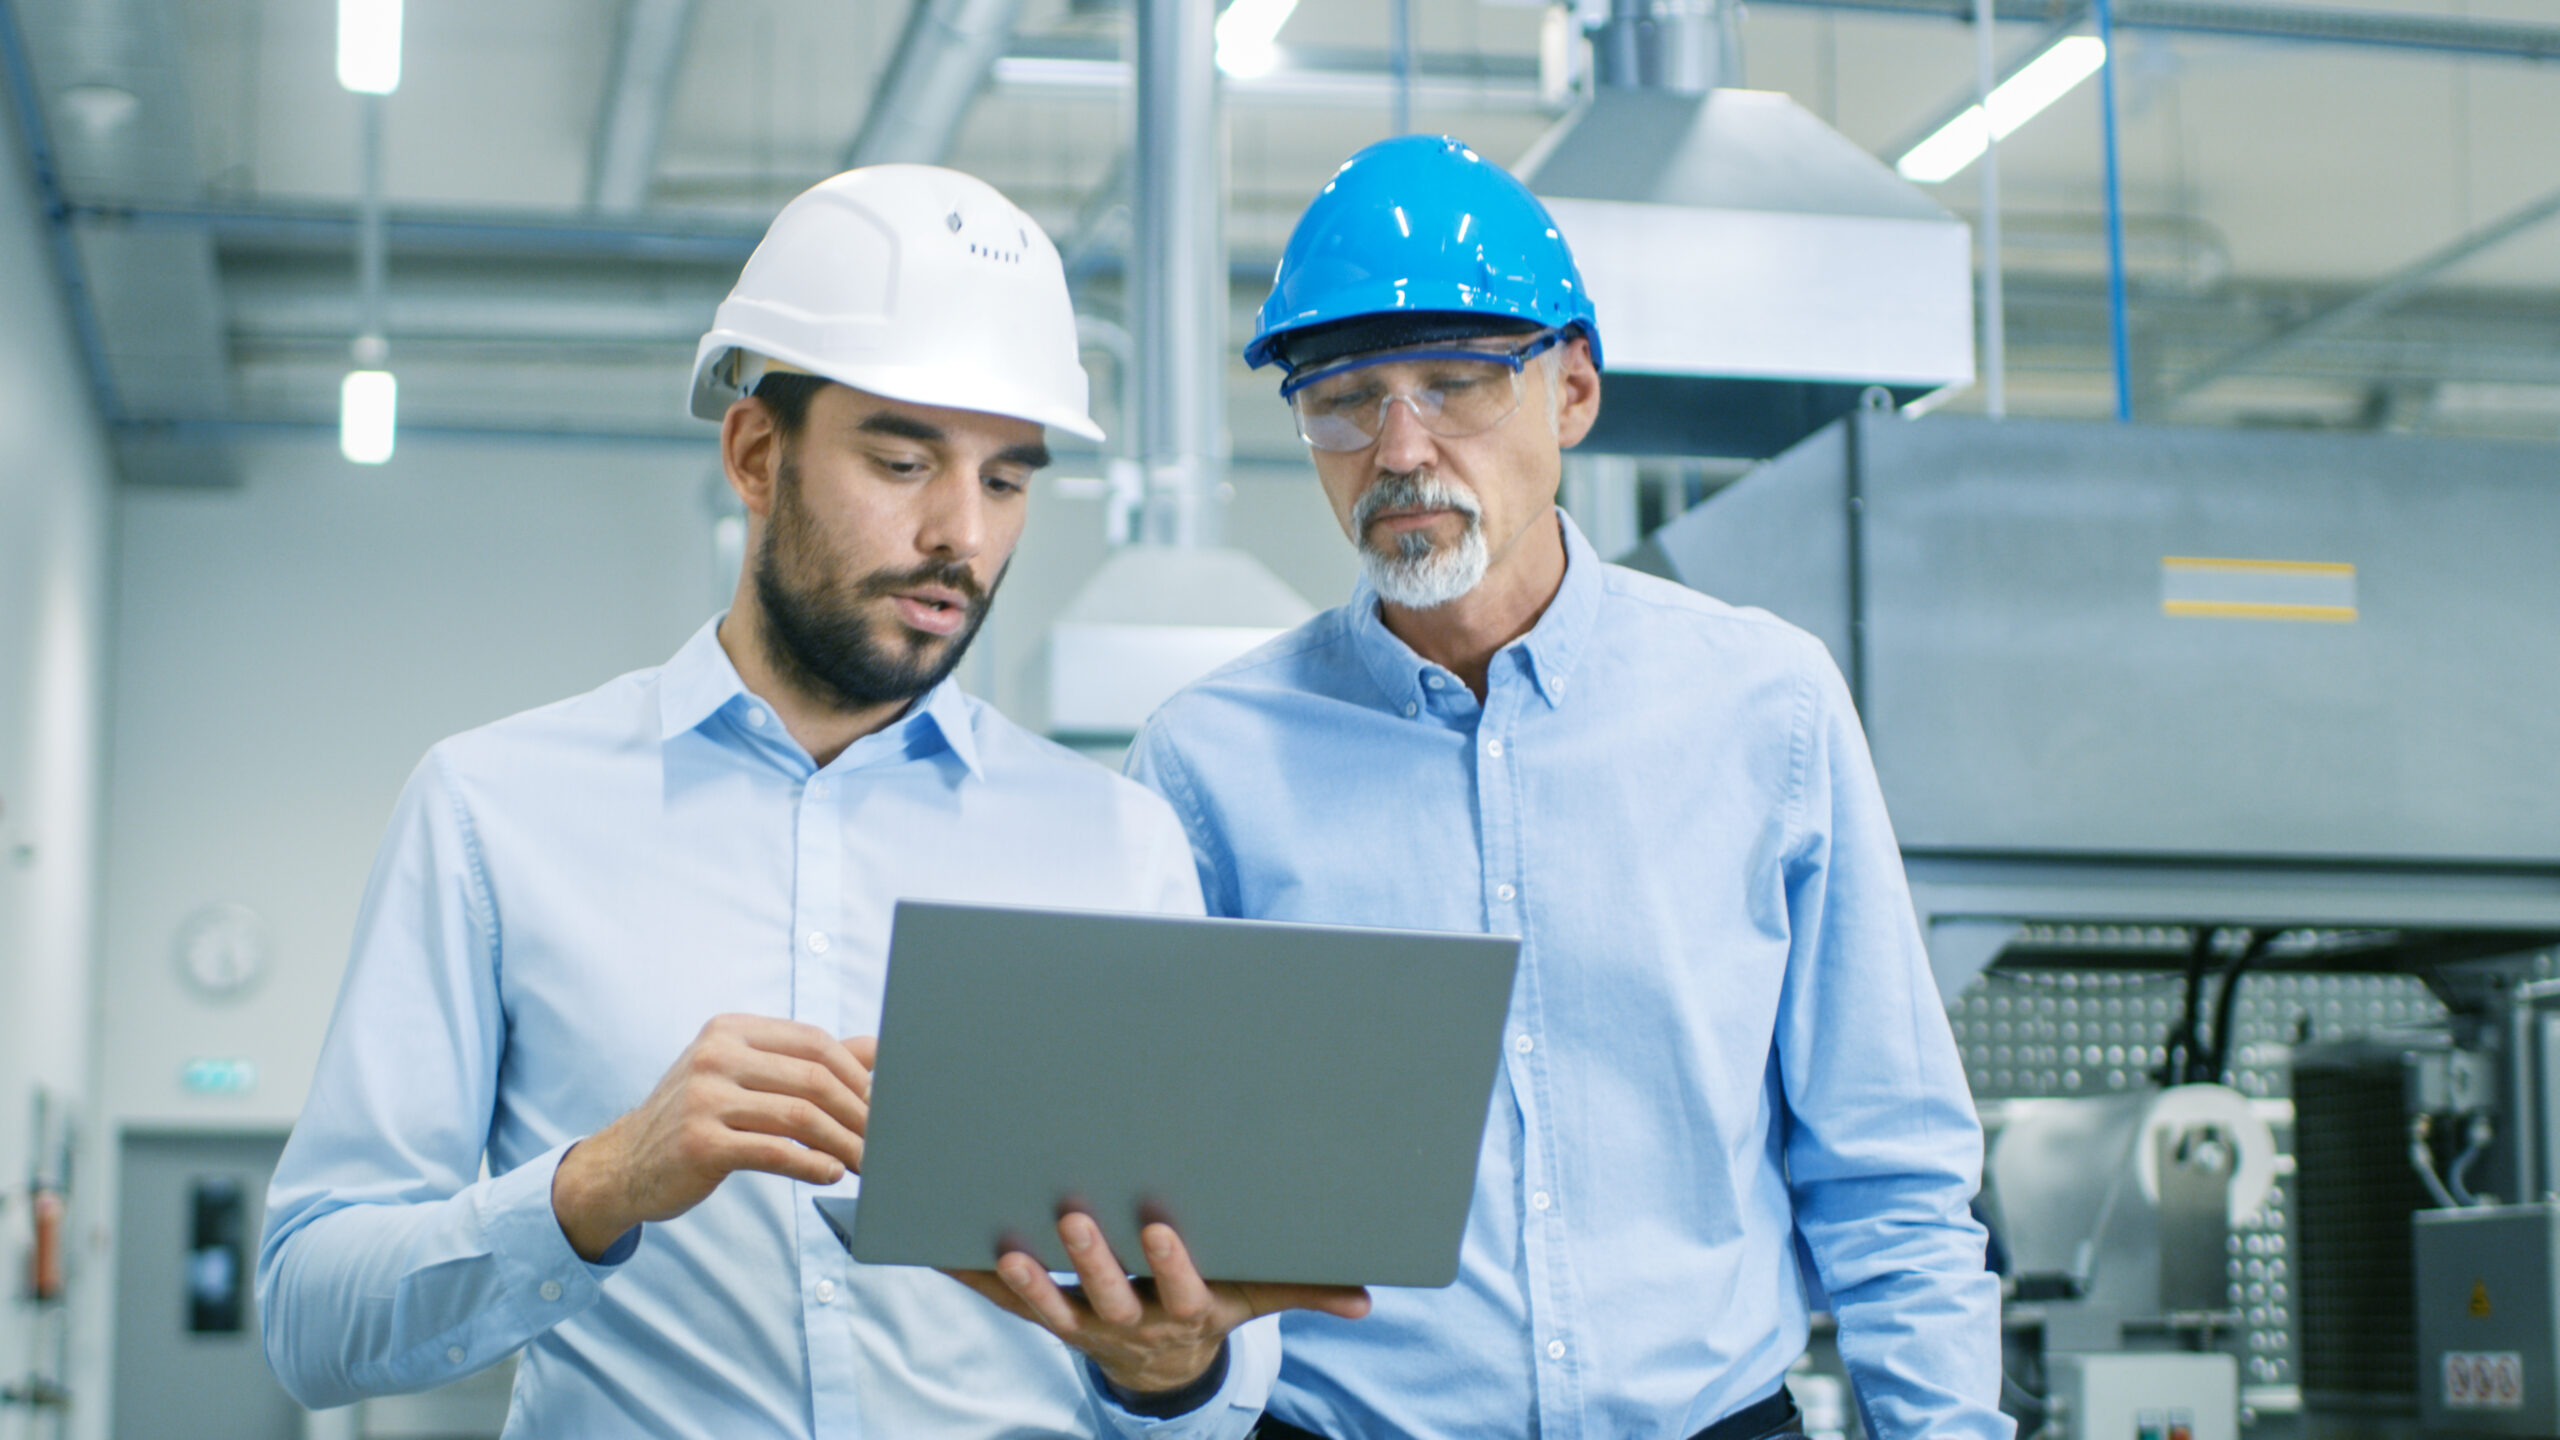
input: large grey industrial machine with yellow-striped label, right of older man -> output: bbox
[1631,409,2560,1440]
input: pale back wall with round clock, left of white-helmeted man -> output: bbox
[100,428,717,1127]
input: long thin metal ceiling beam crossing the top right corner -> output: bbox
[1759,0,2560,59]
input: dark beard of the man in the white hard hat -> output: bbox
[755,456,1004,712]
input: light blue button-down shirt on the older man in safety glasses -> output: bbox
[1129,515,2012,1440]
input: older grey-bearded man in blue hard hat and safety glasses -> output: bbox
[1129,136,2010,1440]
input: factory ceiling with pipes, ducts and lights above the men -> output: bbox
[15,0,2560,471]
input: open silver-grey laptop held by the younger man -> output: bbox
[817,902,1521,1286]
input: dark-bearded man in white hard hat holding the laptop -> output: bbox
[259,167,1362,1437]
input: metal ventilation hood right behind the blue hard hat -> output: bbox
[1518,77,1974,456]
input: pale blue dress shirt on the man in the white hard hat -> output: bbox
[259,625,1277,1440]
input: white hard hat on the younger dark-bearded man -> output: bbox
[694,164,1103,441]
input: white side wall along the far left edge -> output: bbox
[0,81,113,1437]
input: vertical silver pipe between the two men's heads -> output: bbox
[1132,0,1229,546]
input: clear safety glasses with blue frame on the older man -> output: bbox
[1280,331,1564,451]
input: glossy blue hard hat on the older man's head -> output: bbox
[1244,136,1600,369]
